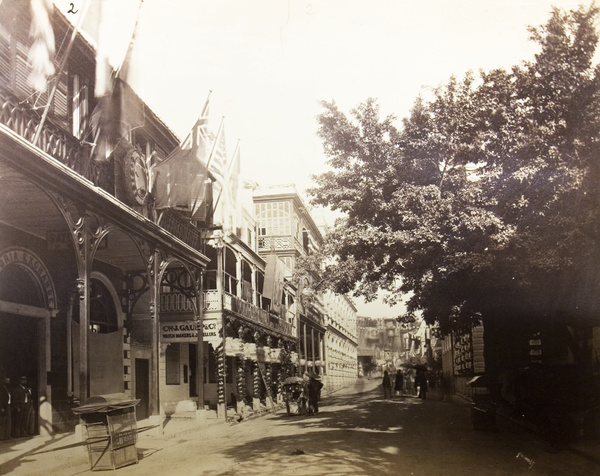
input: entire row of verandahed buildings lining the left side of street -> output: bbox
[0,0,356,434]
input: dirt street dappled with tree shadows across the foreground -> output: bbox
[0,381,600,476]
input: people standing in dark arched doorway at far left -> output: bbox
[0,377,35,440]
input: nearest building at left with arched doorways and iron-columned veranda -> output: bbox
[0,0,209,433]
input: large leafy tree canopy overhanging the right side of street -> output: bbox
[305,7,600,332]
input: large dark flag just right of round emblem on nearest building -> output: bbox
[152,99,209,213]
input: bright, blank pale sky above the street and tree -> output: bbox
[56,0,590,317]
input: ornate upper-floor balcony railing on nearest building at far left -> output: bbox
[0,88,114,191]
